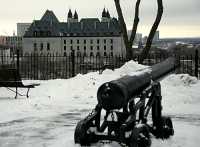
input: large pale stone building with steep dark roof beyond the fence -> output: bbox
[23,9,126,56]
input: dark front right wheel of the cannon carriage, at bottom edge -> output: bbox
[129,125,151,147]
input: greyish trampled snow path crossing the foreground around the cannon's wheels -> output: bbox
[0,110,200,147]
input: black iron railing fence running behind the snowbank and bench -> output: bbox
[0,51,200,80]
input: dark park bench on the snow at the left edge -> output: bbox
[0,68,39,99]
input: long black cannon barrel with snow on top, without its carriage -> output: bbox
[97,57,177,110]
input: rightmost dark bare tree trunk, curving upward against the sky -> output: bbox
[139,0,163,64]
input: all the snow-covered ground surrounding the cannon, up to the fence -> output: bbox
[0,61,200,147]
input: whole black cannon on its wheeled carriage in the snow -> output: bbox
[74,57,178,147]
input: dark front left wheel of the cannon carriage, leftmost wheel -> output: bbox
[74,120,90,146]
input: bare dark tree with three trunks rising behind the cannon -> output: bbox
[114,0,163,63]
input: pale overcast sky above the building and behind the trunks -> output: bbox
[0,0,200,37]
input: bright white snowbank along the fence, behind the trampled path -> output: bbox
[0,61,200,121]
